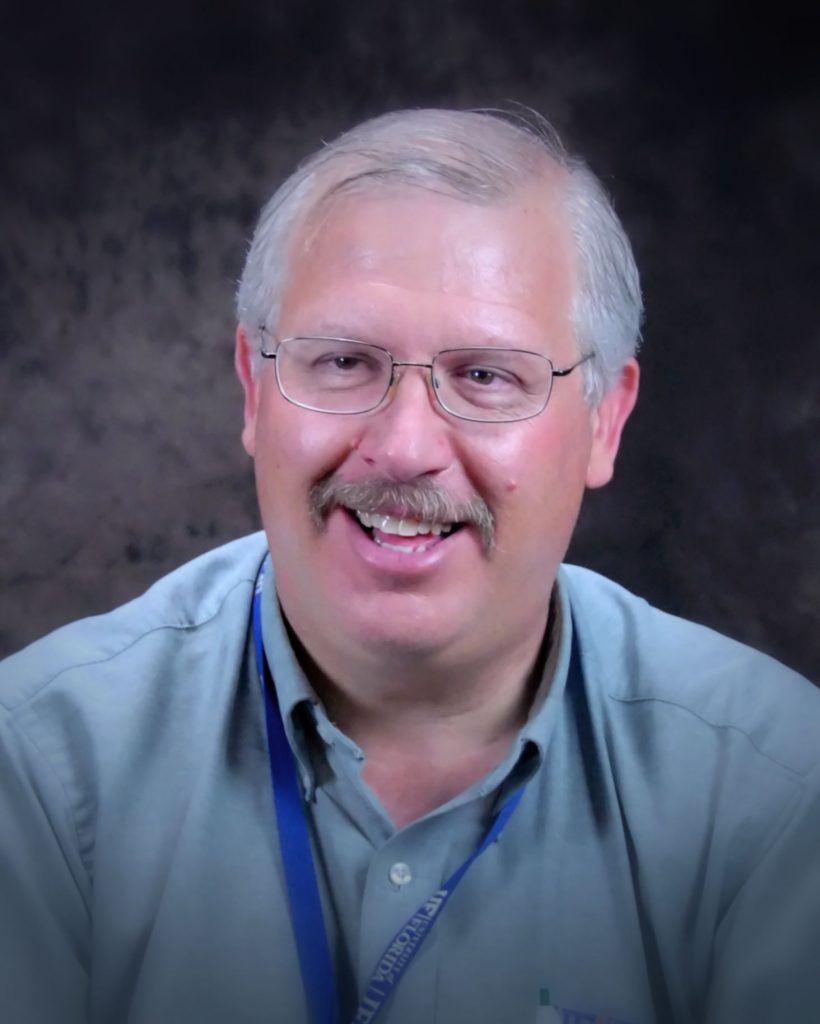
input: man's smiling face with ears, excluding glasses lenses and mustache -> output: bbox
[238,183,637,664]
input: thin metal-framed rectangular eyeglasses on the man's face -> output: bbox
[260,327,595,423]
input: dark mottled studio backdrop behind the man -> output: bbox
[0,0,820,679]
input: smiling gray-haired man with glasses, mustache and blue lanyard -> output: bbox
[0,111,820,1024]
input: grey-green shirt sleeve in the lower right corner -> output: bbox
[706,770,820,1024]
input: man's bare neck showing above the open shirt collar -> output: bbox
[284,609,553,826]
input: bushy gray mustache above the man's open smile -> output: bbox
[310,476,495,554]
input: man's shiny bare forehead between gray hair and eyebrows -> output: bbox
[282,175,575,344]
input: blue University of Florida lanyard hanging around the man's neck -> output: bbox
[253,562,524,1024]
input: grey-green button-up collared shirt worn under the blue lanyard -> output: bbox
[0,536,820,1024]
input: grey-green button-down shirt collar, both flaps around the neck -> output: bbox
[262,555,572,799]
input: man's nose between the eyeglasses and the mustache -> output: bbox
[358,364,454,482]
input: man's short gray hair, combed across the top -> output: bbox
[236,110,643,406]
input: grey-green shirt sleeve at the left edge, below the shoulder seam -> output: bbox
[0,709,90,1024]
